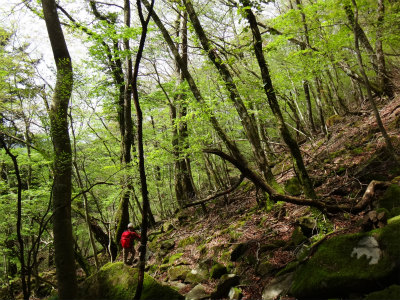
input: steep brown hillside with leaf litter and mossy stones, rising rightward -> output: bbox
[141,93,400,299]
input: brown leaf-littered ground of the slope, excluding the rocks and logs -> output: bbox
[144,92,400,299]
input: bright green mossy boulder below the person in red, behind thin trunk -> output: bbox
[78,262,184,300]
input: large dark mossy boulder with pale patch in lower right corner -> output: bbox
[289,217,400,299]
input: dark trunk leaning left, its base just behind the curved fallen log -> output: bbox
[241,0,316,199]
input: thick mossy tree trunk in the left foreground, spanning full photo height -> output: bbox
[42,0,77,299]
